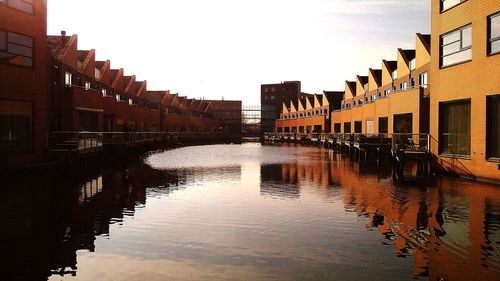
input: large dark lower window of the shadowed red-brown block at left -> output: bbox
[0,101,33,153]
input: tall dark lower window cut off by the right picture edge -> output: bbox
[486,95,500,159]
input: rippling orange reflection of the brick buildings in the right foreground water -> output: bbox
[330,160,500,280]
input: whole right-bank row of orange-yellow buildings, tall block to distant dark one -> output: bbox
[261,0,500,181]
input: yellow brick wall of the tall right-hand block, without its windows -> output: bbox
[429,0,500,180]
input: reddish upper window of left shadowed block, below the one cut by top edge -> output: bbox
[0,30,33,67]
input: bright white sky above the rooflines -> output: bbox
[48,0,430,105]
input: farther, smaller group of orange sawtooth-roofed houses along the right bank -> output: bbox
[275,91,344,134]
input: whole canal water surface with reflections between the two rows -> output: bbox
[0,144,500,280]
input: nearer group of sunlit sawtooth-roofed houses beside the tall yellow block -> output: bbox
[331,34,430,135]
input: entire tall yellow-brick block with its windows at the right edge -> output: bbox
[430,0,500,180]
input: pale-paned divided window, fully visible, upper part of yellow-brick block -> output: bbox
[441,25,472,67]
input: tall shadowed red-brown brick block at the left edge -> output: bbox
[0,0,49,166]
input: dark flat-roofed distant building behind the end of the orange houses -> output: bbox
[260,81,301,133]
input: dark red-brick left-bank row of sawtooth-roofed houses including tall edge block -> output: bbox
[0,0,241,166]
